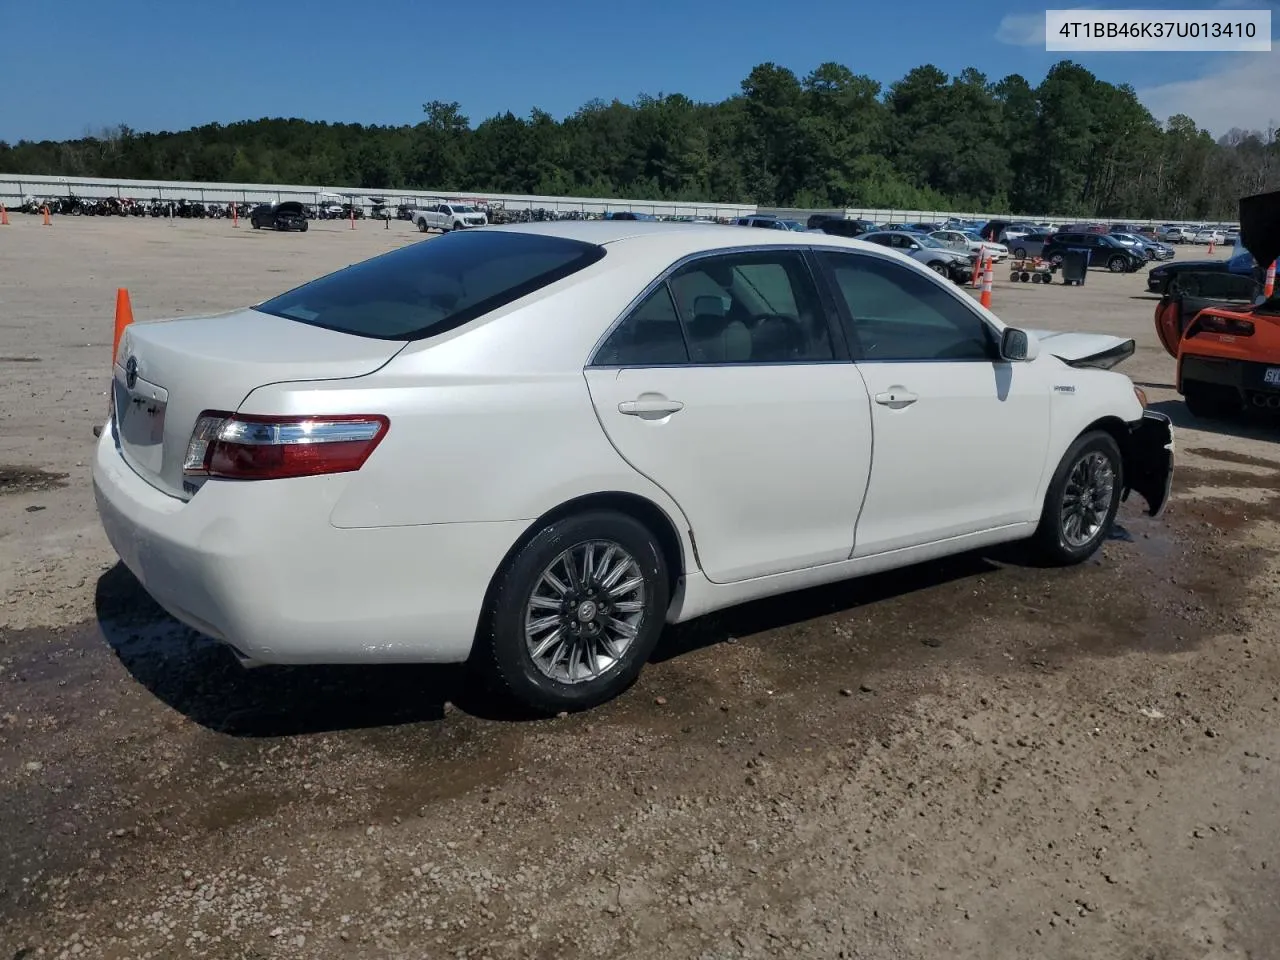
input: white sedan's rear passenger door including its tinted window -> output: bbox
[586,248,872,582]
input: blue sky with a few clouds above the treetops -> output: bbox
[0,0,1280,142]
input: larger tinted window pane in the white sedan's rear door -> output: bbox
[668,251,836,364]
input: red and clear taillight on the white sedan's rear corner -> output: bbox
[182,410,390,480]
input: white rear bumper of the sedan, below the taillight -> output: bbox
[93,430,527,663]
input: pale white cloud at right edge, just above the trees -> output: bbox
[1138,54,1280,137]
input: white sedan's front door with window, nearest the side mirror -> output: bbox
[820,252,1051,557]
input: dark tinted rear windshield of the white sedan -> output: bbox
[256,229,604,340]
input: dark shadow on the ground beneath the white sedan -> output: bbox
[95,548,1028,737]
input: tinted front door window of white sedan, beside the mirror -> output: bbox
[820,251,998,361]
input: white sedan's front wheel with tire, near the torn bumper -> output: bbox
[1032,430,1124,567]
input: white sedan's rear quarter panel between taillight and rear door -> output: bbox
[241,261,689,536]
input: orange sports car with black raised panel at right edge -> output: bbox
[1156,191,1280,417]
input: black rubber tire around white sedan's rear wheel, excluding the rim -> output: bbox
[483,511,669,713]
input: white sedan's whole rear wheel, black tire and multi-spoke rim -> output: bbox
[476,511,669,713]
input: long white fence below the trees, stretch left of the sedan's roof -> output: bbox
[0,173,755,218]
